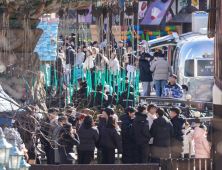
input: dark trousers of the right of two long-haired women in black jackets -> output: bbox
[102,147,115,164]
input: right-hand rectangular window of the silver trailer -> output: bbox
[197,60,214,76]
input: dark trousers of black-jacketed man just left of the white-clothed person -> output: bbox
[137,142,149,163]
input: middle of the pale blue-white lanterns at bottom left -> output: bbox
[9,140,23,170]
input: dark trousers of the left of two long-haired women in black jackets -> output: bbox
[77,150,94,164]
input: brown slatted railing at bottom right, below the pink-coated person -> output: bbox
[160,158,212,170]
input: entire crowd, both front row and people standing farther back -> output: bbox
[13,35,210,164]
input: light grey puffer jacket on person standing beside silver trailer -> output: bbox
[150,58,172,80]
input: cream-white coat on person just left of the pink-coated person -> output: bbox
[184,127,195,154]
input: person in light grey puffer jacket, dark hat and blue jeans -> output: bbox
[150,51,172,97]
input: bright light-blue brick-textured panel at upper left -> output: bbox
[34,21,58,61]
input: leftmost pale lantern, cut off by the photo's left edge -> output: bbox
[0,127,12,170]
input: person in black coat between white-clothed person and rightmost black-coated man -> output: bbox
[150,108,173,163]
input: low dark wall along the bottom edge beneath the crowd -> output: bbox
[29,164,159,170]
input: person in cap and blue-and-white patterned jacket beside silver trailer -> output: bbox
[162,74,183,101]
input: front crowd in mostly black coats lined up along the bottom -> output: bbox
[14,104,210,165]
